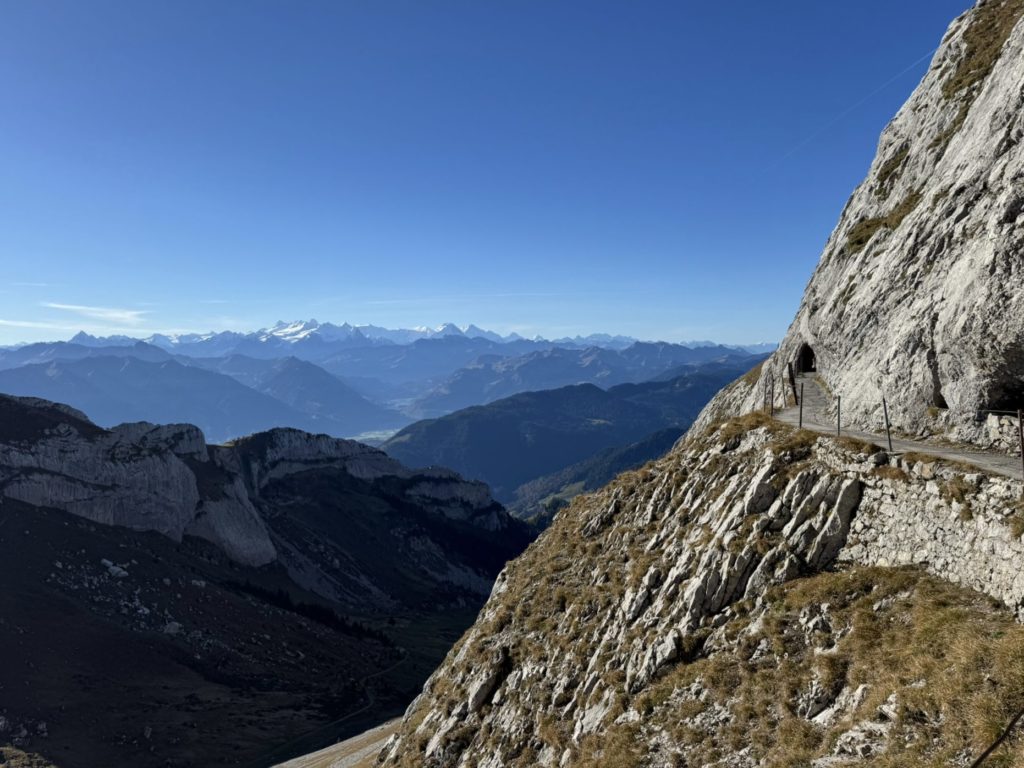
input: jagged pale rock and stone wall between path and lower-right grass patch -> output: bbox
[382,418,1024,768]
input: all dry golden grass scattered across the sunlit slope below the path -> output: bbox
[382,414,1024,768]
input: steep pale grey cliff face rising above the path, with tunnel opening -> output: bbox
[699,0,1024,447]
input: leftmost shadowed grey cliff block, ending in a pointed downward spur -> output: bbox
[0,397,276,565]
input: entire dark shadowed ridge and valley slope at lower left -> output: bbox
[0,393,532,768]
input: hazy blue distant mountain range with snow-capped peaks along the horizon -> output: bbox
[0,321,770,441]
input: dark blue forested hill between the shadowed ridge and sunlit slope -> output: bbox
[381,357,760,507]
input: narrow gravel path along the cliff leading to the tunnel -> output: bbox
[775,374,1024,479]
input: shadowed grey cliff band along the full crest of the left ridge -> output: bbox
[0,395,514,573]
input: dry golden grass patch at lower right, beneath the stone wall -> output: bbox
[582,568,1024,768]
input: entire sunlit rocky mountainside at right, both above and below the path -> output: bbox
[379,0,1024,768]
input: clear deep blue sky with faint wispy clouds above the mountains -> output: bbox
[0,0,968,344]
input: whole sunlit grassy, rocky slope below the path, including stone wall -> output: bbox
[381,416,1024,768]
